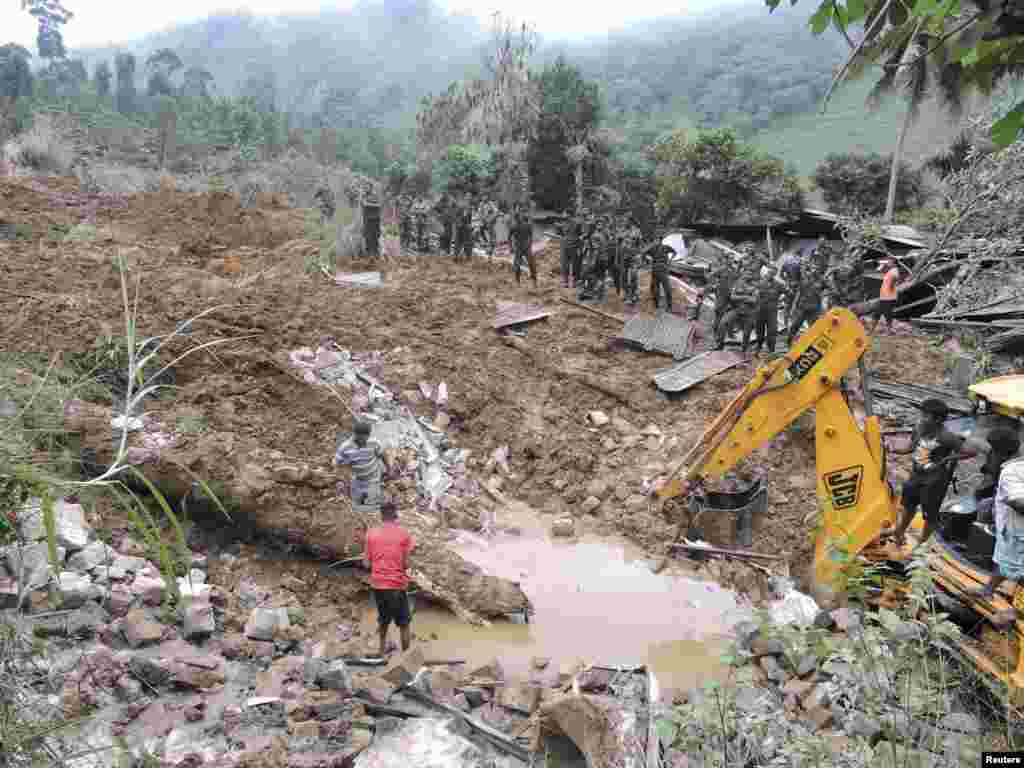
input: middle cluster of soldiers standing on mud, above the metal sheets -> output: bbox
[561,208,647,309]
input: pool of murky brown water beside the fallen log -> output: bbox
[362,505,746,697]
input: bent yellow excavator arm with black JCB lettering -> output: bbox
[656,308,897,587]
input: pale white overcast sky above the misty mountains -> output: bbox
[0,0,752,53]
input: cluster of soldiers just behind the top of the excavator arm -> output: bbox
[698,238,863,354]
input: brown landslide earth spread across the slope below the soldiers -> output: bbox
[0,179,943,602]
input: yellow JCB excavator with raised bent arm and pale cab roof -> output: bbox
[655,308,1024,694]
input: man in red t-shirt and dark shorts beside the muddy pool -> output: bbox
[362,501,413,656]
